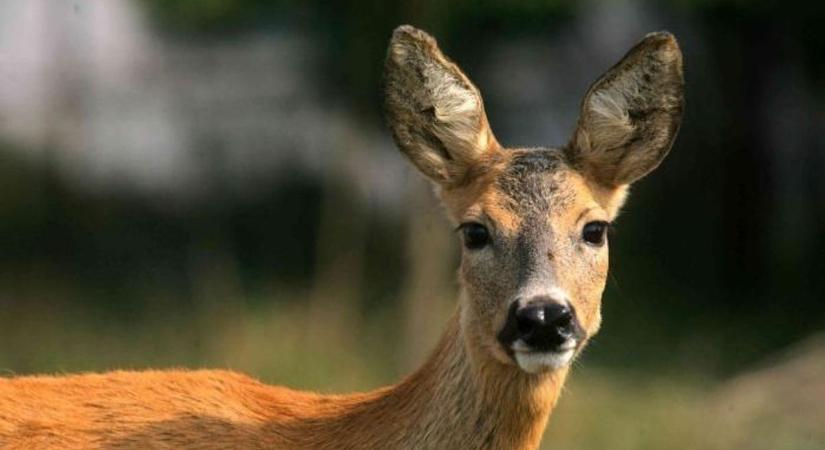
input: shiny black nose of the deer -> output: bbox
[513,298,578,351]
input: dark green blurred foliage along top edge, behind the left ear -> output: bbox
[142,0,574,117]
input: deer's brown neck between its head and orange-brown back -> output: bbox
[300,302,566,450]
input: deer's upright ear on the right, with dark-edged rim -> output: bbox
[566,32,685,187]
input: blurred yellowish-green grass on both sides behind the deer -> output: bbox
[0,302,825,450]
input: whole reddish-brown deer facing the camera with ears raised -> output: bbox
[0,25,684,450]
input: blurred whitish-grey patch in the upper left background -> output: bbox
[0,0,392,202]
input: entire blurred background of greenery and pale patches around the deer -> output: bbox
[0,0,825,449]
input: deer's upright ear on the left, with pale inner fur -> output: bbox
[384,25,498,185]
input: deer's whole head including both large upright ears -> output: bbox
[385,26,684,373]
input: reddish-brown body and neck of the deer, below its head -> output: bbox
[0,319,564,450]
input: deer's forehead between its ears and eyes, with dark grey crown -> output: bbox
[441,149,624,236]
